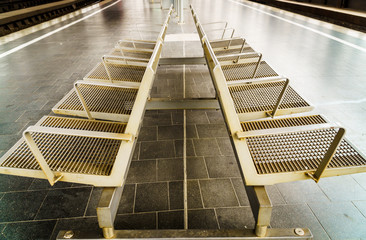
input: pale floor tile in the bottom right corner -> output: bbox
[309,202,366,239]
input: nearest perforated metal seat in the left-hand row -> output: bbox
[0,116,134,186]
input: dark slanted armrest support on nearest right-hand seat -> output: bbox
[312,128,346,182]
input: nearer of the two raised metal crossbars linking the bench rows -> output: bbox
[146,98,220,110]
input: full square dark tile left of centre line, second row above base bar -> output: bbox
[135,183,169,212]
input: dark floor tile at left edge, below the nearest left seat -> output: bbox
[0,191,47,222]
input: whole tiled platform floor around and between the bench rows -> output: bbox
[0,0,366,240]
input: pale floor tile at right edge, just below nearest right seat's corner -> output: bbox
[318,175,366,201]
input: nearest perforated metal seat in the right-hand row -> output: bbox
[239,115,366,184]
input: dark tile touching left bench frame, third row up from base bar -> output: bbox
[126,160,156,183]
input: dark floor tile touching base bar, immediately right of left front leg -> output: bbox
[114,213,157,229]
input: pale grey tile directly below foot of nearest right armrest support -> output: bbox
[276,180,329,203]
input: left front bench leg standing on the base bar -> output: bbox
[97,187,123,239]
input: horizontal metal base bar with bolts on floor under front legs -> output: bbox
[56,228,313,240]
